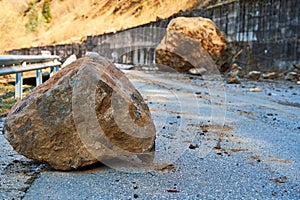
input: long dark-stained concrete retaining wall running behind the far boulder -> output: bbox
[8,0,300,71]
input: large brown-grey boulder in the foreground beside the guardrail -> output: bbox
[4,57,155,170]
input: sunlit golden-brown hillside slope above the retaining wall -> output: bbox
[0,0,218,53]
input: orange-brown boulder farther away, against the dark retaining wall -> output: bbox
[156,17,233,72]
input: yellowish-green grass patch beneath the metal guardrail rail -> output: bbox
[0,85,34,116]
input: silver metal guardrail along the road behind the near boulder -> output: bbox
[0,55,61,99]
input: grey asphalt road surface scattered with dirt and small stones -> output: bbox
[0,70,300,200]
